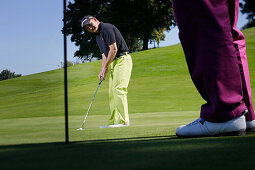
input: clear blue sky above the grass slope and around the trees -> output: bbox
[0,0,247,76]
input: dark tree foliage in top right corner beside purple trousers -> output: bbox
[240,0,255,28]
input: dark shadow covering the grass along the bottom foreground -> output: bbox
[0,133,255,169]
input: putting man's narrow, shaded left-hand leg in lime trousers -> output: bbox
[108,62,118,125]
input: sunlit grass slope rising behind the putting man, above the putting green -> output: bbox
[0,45,202,119]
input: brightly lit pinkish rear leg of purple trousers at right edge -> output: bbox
[228,0,255,121]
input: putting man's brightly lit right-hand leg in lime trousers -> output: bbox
[112,55,133,124]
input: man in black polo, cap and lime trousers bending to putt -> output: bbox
[81,15,133,128]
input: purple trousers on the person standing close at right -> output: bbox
[173,0,255,122]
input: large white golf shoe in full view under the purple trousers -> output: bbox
[176,110,247,137]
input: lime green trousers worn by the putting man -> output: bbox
[108,54,133,125]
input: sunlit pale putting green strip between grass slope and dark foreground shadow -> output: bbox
[0,111,199,145]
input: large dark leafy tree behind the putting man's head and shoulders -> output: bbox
[66,0,175,58]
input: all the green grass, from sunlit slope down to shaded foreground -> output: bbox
[0,27,255,169]
